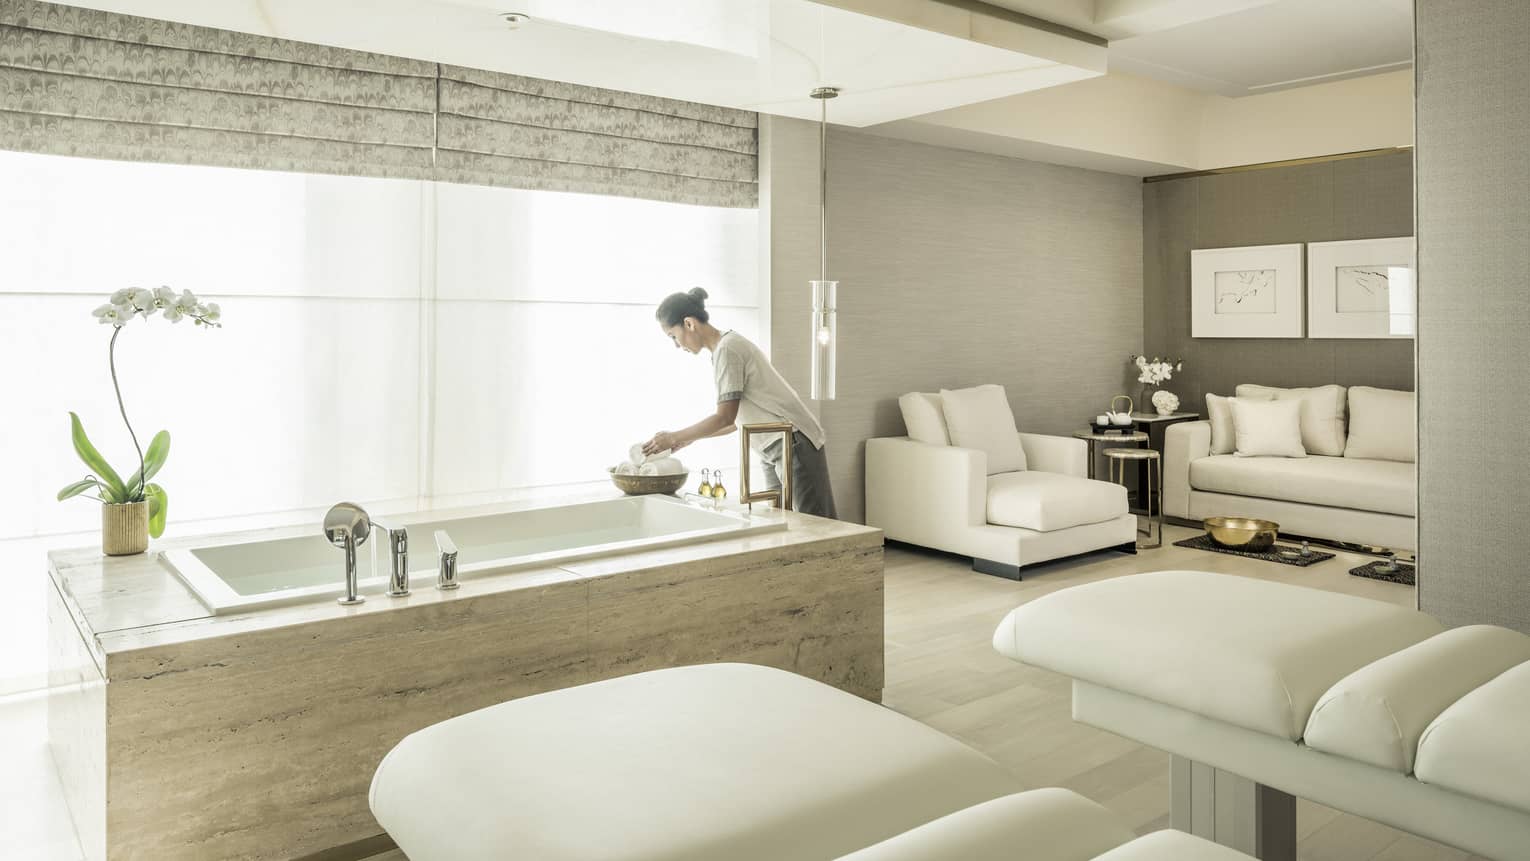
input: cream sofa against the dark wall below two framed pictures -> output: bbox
[1163,385,1418,549]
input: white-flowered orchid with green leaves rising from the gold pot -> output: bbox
[58,288,222,538]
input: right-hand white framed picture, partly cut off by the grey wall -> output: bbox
[1307,236,1417,338]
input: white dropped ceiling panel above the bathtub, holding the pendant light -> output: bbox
[59,0,1106,125]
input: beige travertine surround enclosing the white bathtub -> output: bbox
[49,506,883,859]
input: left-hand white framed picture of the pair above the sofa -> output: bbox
[1190,242,1305,338]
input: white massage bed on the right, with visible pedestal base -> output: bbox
[993,570,1530,861]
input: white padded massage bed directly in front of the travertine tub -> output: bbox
[370,664,1248,861]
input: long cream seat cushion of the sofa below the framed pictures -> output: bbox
[1190,454,1417,517]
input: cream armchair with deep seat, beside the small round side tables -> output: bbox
[866,388,1137,580]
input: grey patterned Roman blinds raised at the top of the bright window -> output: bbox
[0,0,757,206]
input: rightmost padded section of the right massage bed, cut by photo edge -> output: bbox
[1414,664,1530,812]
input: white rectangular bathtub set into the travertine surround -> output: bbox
[161,495,786,615]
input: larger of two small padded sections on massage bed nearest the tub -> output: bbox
[838,789,1132,861]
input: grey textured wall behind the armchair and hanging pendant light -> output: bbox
[762,118,1143,520]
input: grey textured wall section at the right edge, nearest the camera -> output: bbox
[1415,0,1530,633]
